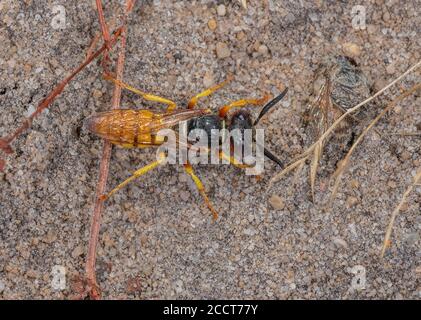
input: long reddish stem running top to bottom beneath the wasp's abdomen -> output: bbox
[85,0,134,299]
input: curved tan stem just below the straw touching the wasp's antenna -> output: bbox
[329,84,421,204]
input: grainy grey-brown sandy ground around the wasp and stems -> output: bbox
[0,0,421,299]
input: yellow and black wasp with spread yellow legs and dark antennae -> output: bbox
[85,74,287,220]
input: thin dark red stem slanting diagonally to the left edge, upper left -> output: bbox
[0,27,122,171]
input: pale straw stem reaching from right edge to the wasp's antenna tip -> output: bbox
[268,61,421,189]
